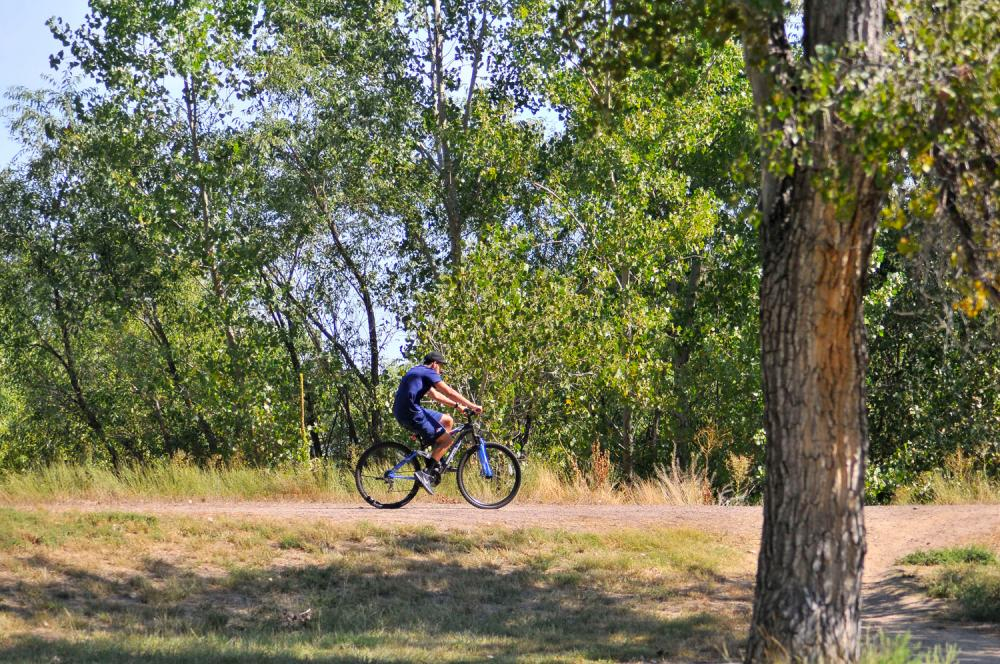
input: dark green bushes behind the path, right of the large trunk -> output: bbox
[866,222,1000,501]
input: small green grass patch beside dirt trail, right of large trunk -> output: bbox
[899,546,1000,623]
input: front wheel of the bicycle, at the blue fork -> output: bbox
[458,443,521,510]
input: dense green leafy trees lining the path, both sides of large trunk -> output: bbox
[0,0,1000,502]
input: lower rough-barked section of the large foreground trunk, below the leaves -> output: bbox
[747,163,879,662]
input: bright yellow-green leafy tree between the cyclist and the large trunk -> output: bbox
[406,37,759,481]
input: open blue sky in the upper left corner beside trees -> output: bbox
[0,0,87,168]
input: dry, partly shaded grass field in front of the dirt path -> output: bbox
[0,508,753,664]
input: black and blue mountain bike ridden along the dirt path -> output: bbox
[354,409,524,509]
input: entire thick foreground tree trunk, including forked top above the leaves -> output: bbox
[745,0,885,662]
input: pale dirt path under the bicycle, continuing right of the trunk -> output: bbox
[15,500,1000,664]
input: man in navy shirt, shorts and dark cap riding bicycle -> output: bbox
[392,351,483,494]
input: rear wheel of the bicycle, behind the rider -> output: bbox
[354,443,420,509]
